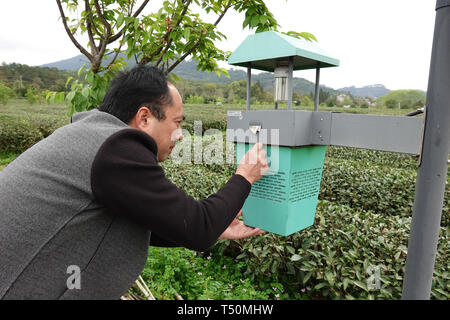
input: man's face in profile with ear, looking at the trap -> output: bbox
[130,83,184,161]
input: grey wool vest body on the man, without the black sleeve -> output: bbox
[0,110,150,299]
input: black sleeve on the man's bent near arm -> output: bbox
[91,129,251,251]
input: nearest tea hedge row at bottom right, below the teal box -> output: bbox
[212,200,450,299]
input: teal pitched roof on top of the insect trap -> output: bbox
[228,31,339,72]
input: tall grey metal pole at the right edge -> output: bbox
[402,0,450,300]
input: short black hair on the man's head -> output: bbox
[98,66,173,123]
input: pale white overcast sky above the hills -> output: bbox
[0,0,436,90]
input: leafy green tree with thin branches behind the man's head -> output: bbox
[53,0,316,114]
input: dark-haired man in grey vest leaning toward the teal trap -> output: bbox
[0,67,268,299]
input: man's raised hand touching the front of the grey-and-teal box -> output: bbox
[236,143,269,184]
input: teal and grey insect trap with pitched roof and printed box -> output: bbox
[227,31,339,236]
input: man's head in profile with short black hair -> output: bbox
[98,66,184,161]
